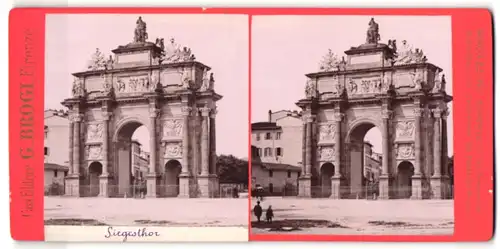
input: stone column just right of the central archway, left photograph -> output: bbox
[146,107,160,198]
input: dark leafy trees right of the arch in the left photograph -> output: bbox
[217,155,248,186]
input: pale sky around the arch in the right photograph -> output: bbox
[251,16,453,155]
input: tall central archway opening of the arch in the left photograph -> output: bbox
[113,119,149,197]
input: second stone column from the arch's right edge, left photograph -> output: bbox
[198,107,210,198]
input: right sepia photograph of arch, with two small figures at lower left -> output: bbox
[250,15,455,235]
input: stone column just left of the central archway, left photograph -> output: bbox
[99,112,112,197]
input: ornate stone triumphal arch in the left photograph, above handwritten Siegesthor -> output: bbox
[62,17,222,198]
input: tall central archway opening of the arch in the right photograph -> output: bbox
[348,119,382,198]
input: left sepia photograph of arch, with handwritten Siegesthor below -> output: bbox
[44,14,249,241]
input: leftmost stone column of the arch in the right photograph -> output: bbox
[299,114,313,197]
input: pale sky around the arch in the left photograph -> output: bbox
[44,14,249,157]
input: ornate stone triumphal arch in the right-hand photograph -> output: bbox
[297,18,452,199]
